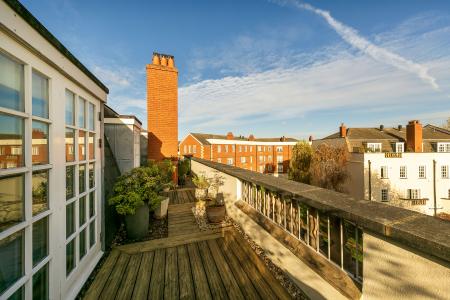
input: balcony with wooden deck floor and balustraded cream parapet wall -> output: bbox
[85,158,450,299]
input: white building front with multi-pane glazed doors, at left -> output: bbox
[0,0,108,299]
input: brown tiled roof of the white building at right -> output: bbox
[313,124,450,152]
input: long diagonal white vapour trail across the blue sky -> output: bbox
[280,0,439,90]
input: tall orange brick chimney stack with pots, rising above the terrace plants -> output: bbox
[146,52,178,160]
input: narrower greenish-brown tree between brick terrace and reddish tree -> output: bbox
[288,141,313,184]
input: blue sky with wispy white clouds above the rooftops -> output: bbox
[21,0,450,139]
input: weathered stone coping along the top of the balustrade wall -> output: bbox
[191,157,450,262]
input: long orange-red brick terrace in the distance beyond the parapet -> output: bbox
[179,132,298,175]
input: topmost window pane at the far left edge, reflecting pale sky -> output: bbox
[0,53,25,111]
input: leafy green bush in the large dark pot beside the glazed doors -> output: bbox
[108,163,172,215]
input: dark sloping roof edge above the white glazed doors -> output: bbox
[3,0,109,94]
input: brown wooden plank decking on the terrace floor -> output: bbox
[85,191,289,299]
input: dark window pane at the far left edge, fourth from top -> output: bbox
[0,230,24,295]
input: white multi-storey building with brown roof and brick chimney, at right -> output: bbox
[313,121,450,215]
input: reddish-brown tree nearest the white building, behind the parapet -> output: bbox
[310,144,349,192]
